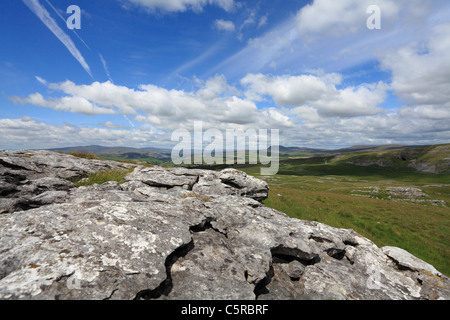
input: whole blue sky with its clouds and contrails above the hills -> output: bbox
[0,0,450,149]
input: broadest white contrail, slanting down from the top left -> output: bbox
[22,0,93,78]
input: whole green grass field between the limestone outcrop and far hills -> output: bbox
[240,157,450,275]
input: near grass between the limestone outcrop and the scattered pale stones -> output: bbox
[265,181,450,274]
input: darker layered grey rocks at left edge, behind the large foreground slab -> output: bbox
[0,150,133,213]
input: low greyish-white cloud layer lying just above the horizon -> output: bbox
[0,103,450,149]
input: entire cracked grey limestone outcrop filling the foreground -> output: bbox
[0,151,450,300]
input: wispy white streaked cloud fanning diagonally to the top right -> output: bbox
[211,0,450,78]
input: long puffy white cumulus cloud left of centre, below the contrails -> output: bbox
[10,75,296,129]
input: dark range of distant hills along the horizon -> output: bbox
[50,144,450,173]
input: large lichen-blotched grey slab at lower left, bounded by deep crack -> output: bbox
[0,201,195,299]
